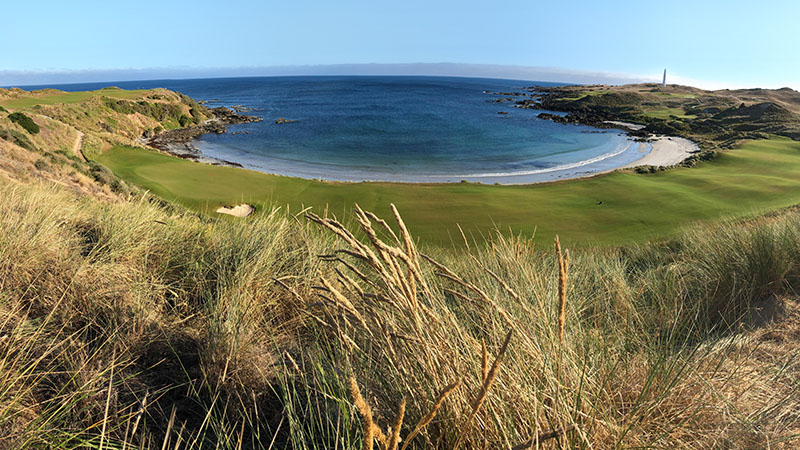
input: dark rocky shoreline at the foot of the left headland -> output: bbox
[147,106,262,167]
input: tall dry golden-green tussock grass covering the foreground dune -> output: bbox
[0,178,800,450]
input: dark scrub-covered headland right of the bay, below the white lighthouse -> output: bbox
[528,84,800,149]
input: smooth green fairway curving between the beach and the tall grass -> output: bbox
[97,138,800,245]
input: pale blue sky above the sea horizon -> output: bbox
[0,0,800,89]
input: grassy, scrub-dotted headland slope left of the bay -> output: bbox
[0,88,254,199]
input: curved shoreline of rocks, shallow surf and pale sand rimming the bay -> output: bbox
[144,90,700,185]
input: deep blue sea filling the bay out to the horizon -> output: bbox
[20,76,644,183]
